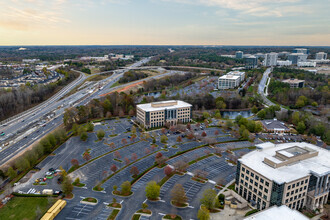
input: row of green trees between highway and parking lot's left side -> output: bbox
[0,129,68,180]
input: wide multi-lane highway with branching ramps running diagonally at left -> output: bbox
[0,58,178,166]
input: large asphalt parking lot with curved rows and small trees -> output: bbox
[14,118,253,219]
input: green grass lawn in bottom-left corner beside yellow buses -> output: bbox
[0,197,55,220]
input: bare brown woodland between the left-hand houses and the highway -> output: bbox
[0,69,78,120]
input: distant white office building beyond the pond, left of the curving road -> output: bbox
[218,71,245,89]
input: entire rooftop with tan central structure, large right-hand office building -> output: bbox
[239,142,330,184]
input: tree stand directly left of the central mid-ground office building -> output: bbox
[63,92,135,130]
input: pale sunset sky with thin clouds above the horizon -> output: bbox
[0,0,330,46]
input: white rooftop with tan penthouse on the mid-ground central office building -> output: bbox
[137,100,192,111]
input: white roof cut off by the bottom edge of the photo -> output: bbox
[244,205,309,220]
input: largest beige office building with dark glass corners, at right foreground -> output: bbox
[235,142,330,210]
